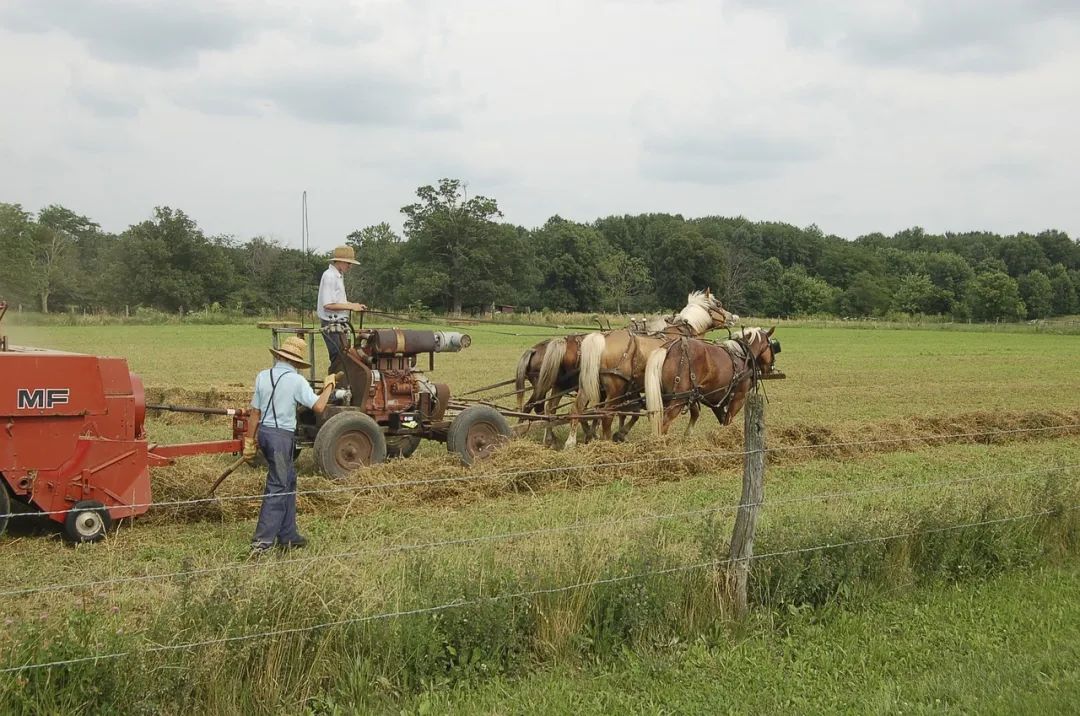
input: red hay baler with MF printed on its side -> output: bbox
[0,303,246,542]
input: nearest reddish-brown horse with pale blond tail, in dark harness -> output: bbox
[645,328,780,435]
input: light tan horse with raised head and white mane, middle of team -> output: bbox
[564,288,739,448]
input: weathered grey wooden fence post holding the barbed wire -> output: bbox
[730,390,765,619]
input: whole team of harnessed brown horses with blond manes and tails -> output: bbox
[515,288,780,448]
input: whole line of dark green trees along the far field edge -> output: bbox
[0,179,1080,321]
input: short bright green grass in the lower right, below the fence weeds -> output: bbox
[397,564,1080,714]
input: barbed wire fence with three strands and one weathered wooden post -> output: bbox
[0,416,1080,674]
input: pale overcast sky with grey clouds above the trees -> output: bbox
[0,0,1080,248]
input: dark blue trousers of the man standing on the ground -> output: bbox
[254,425,300,546]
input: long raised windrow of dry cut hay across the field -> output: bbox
[151,410,1080,521]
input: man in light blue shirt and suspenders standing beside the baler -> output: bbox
[244,336,336,553]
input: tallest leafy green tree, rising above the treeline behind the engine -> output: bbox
[402,179,511,314]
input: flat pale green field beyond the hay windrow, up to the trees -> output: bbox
[8,325,1080,431]
